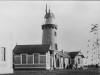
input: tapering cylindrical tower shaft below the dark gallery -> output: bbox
[42,24,57,50]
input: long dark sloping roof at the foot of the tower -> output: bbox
[13,45,50,54]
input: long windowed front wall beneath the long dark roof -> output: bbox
[14,53,46,69]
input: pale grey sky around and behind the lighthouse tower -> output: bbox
[0,1,100,51]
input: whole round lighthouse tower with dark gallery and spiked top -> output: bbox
[42,5,58,50]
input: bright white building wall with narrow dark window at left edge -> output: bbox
[0,42,14,74]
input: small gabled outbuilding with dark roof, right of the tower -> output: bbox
[68,51,84,68]
